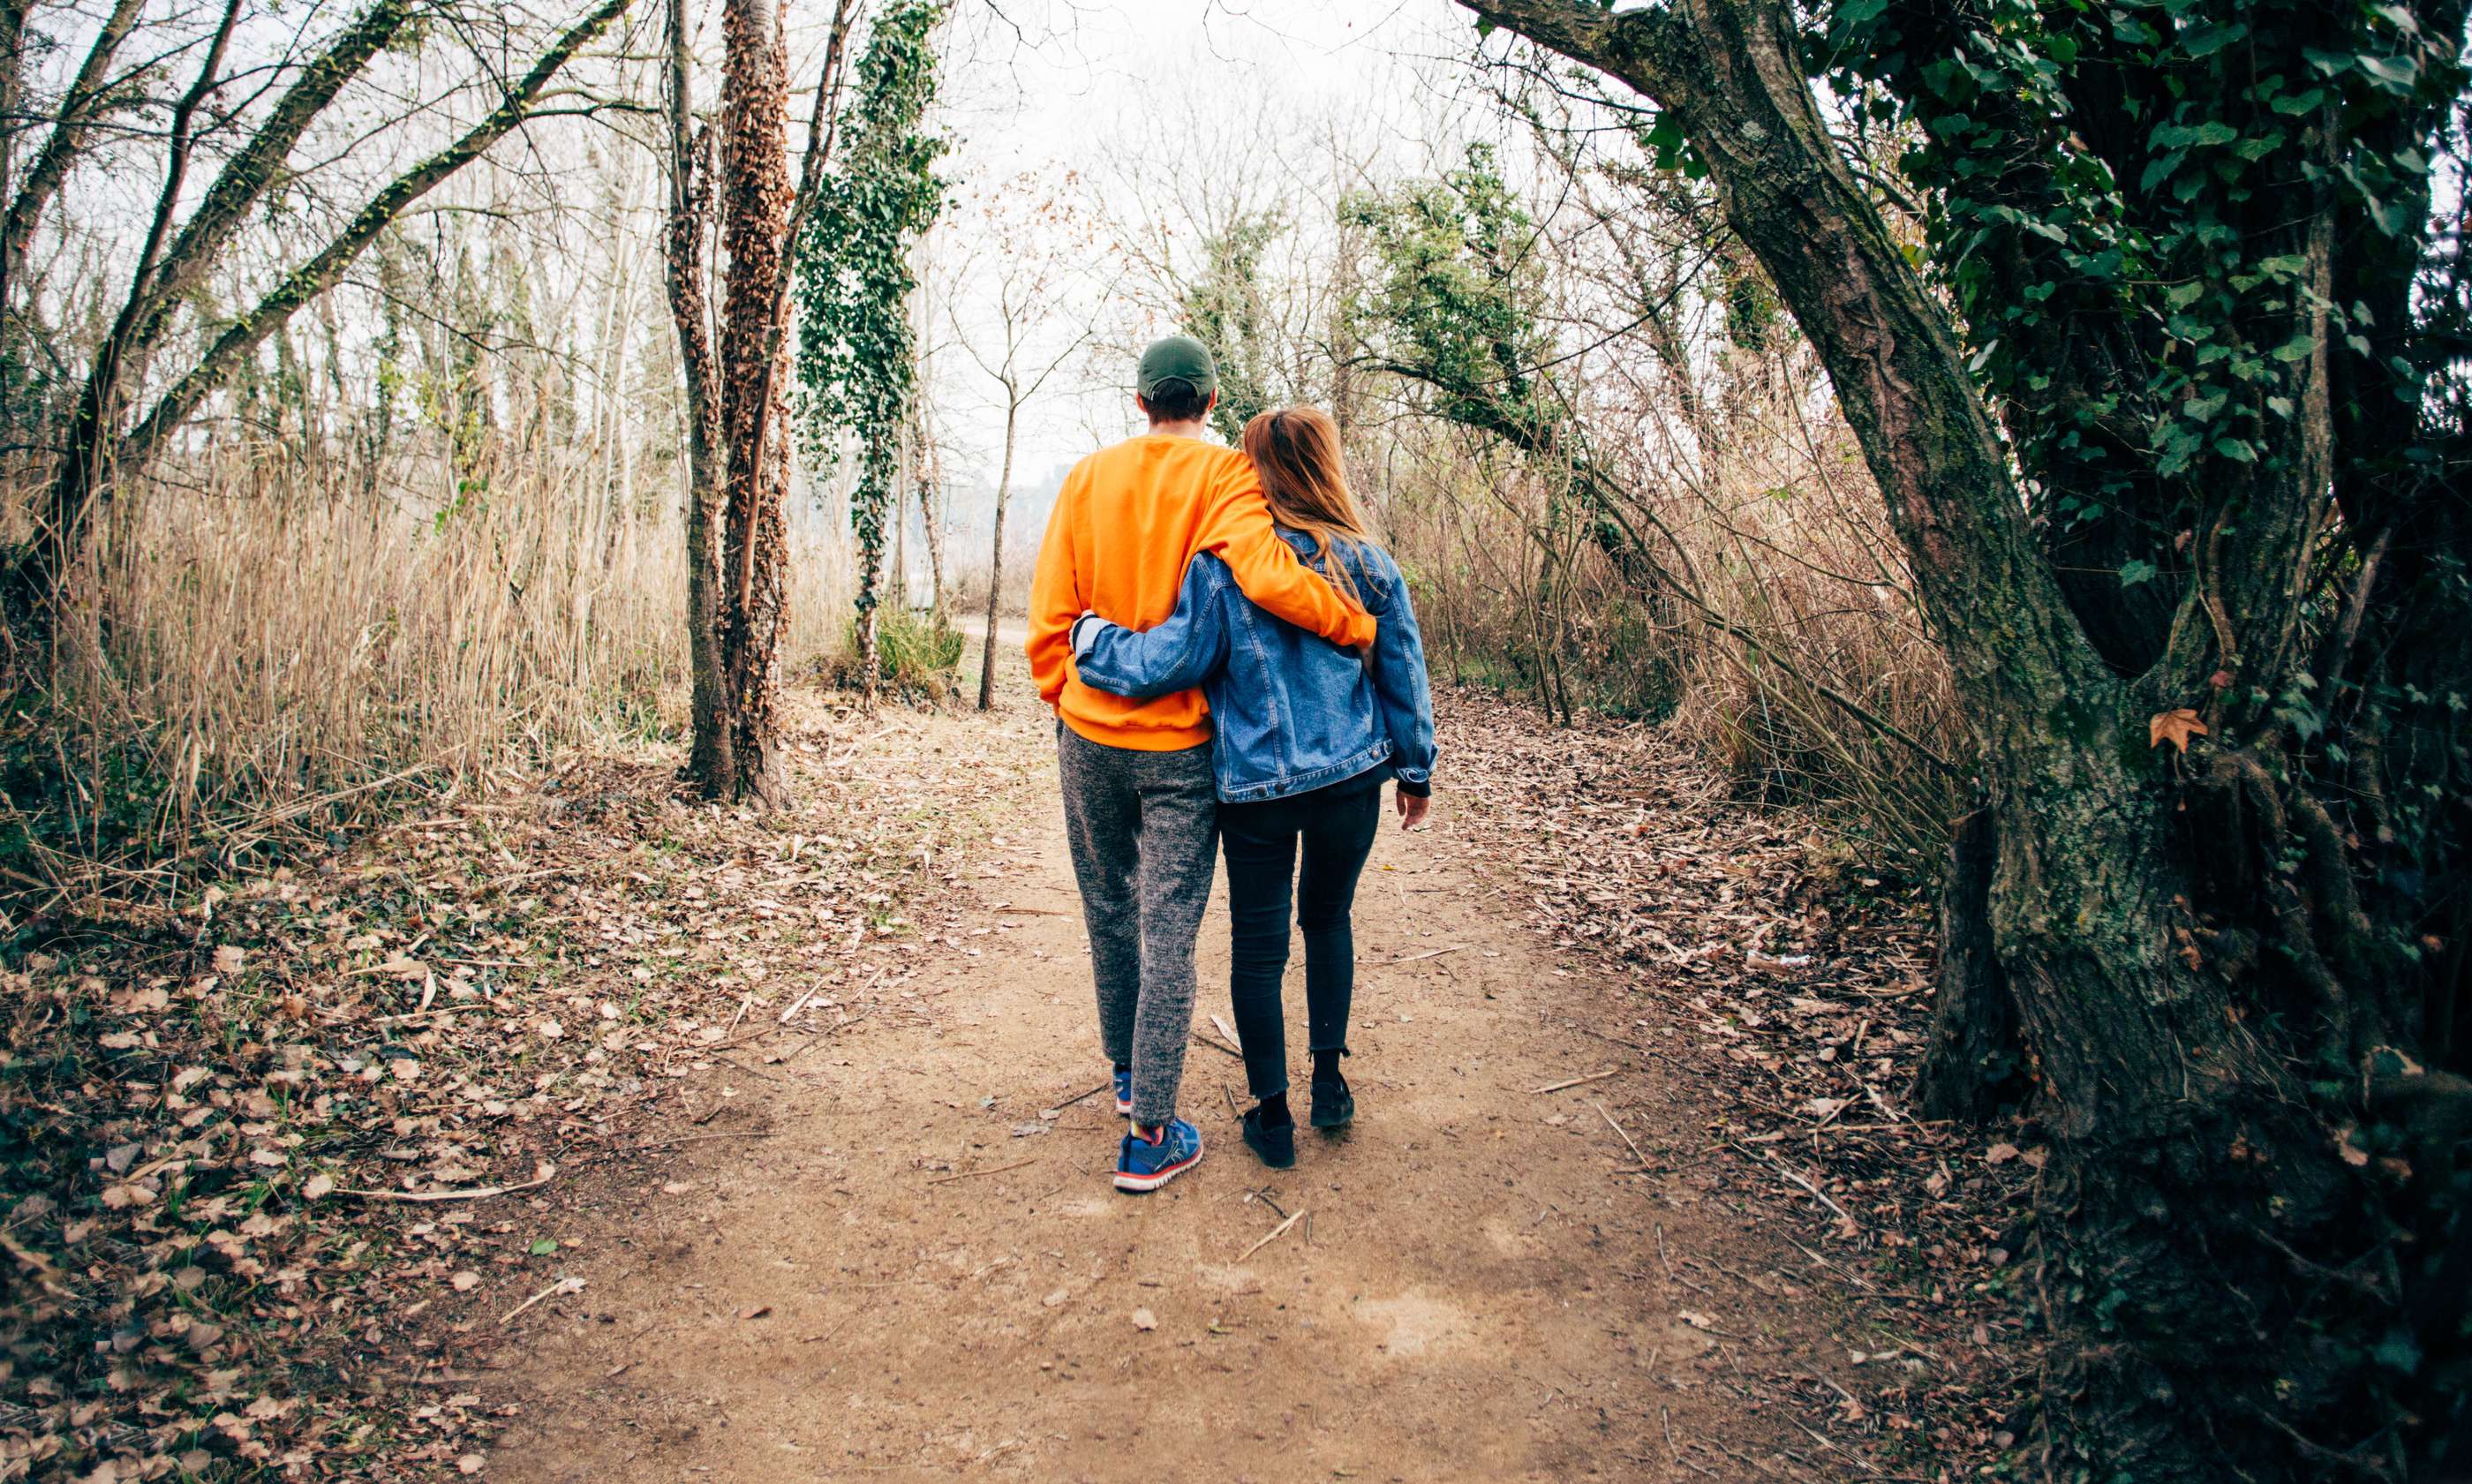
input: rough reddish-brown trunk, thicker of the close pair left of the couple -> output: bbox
[712,0,791,806]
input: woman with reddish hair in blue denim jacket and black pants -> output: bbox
[1073,408,1434,1170]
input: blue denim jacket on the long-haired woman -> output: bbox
[1073,530,1434,804]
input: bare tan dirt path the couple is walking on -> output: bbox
[487,697,1854,1484]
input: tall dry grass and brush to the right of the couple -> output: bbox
[1384,383,1971,876]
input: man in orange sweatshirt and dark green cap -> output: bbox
[1029,334,1375,1190]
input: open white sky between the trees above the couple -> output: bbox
[930,0,1473,522]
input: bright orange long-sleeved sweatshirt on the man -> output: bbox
[1026,433,1375,752]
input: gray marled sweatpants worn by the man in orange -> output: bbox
[1056,725,1218,1126]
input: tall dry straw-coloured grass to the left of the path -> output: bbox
[0,437,846,915]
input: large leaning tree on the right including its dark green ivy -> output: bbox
[1466,0,2472,1481]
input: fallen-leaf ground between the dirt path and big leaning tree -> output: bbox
[1446,692,2046,1479]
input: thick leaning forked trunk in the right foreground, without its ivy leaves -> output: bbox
[1464,0,2462,1479]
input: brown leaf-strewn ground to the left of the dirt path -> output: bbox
[0,697,1011,1484]
